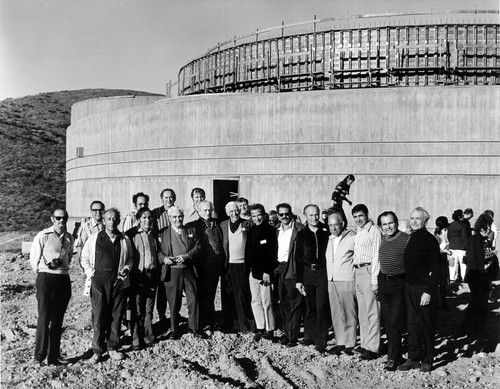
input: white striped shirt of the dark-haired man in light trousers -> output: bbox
[354,219,380,285]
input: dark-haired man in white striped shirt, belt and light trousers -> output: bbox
[352,204,380,360]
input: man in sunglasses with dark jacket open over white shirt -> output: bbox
[276,203,304,347]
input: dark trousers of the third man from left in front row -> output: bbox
[130,270,158,346]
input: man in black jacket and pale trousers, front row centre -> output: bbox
[245,204,278,341]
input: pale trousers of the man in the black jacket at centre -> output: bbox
[249,274,275,331]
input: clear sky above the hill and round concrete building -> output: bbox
[0,0,499,100]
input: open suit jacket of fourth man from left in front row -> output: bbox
[158,226,201,281]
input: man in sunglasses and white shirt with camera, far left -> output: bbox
[30,208,74,365]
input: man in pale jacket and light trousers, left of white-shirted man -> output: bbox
[326,208,358,355]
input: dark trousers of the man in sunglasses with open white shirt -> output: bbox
[278,264,302,341]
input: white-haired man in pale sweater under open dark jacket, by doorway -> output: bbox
[221,201,253,332]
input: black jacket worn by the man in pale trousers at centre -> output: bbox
[245,221,278,280]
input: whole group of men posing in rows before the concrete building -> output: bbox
[30,188,454,371]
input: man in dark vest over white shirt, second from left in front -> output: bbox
[82,208,134,363]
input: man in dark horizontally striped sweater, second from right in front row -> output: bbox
[377,211,410,371]
